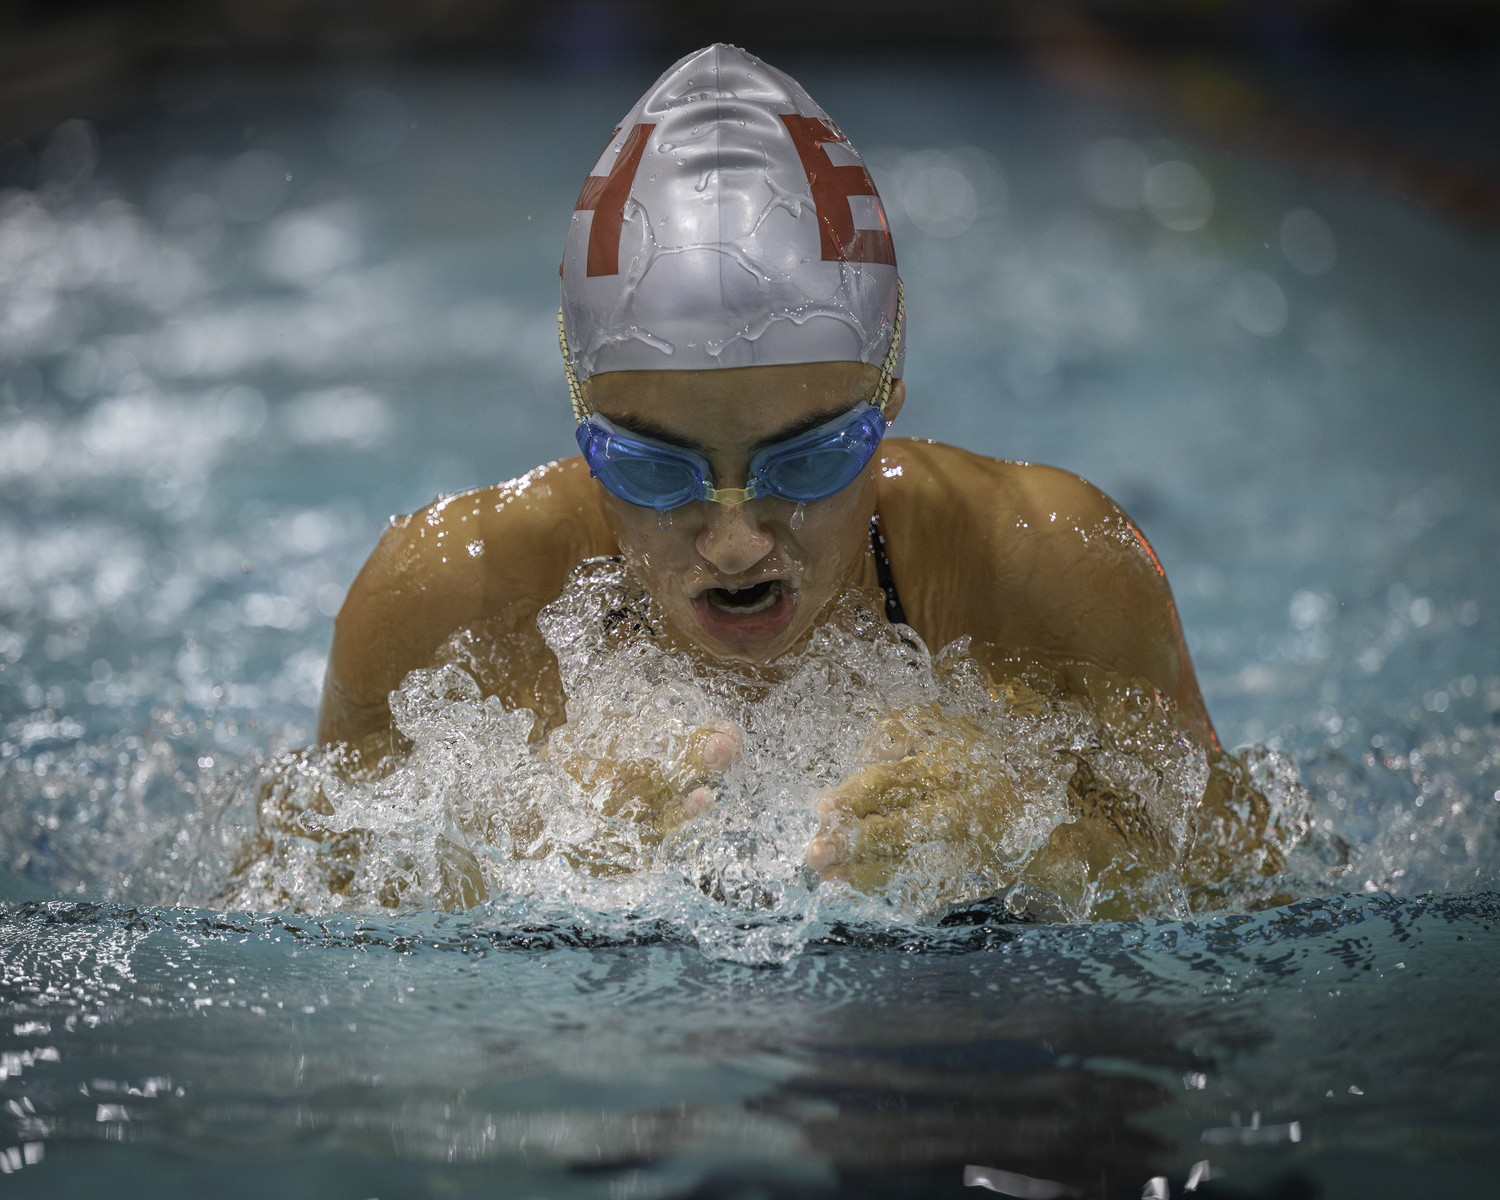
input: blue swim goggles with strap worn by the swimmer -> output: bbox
[558,282,906,512]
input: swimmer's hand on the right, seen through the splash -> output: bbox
[807,705,1022,891]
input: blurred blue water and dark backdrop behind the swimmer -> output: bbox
[0,0,1500,891]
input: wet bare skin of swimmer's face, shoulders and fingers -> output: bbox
[318,363,1217,876]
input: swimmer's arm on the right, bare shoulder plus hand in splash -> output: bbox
[807,456,1218,888]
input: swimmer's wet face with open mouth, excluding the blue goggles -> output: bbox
[584,363,905,662]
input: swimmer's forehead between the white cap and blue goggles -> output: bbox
[584,363,881,446]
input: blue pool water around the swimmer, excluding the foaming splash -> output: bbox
[0,60,1500,1200]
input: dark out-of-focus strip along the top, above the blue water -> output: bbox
[0,0,1500,216]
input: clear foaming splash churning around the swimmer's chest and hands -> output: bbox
[105,560,1329,962]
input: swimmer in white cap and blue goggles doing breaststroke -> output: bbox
[318,45,1302,912]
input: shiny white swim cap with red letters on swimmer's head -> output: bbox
[561,45,905,380]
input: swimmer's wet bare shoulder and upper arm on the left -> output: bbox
[318,459,615,755]
